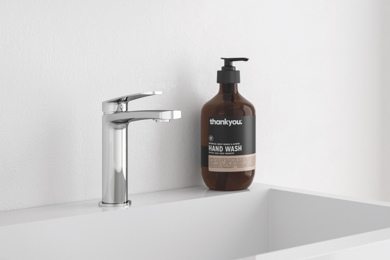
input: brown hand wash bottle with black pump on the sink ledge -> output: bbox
[201,58,256,191]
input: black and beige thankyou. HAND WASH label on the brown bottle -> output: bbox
[202,116,256,172]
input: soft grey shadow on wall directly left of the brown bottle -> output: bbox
[158,58,205,187]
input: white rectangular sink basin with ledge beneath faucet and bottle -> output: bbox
[0,184,390,260]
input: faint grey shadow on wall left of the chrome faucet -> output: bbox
[40,90,83,204]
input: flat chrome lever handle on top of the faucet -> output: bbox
[102,91,162,114]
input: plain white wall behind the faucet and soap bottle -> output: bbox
[0,0,390,210]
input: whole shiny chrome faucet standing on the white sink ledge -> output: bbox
[99,91,181,207]
